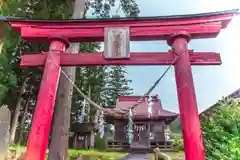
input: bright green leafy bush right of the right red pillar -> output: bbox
[201,100,240,160]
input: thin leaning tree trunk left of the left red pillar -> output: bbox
[9,78,28,145]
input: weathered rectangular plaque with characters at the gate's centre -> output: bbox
[104,27,130,59]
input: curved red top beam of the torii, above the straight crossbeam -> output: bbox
[8,9,238,42]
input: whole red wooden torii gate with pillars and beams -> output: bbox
[7,10,238,160]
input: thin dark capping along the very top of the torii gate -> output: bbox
[0,9,239,23]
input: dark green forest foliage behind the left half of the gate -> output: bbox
[0,0,139,149]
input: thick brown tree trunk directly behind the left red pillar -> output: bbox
[48,0,85,160]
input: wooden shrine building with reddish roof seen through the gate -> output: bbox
[105,96,178,149]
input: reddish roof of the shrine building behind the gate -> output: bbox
[105,96,178,120]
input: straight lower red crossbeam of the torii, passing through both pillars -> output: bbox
[20,50,221,67]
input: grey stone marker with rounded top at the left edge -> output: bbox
[0,106,10,160]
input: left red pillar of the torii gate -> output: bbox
[24,38,69,160]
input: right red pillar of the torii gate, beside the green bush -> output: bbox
[168,32,205,160]
